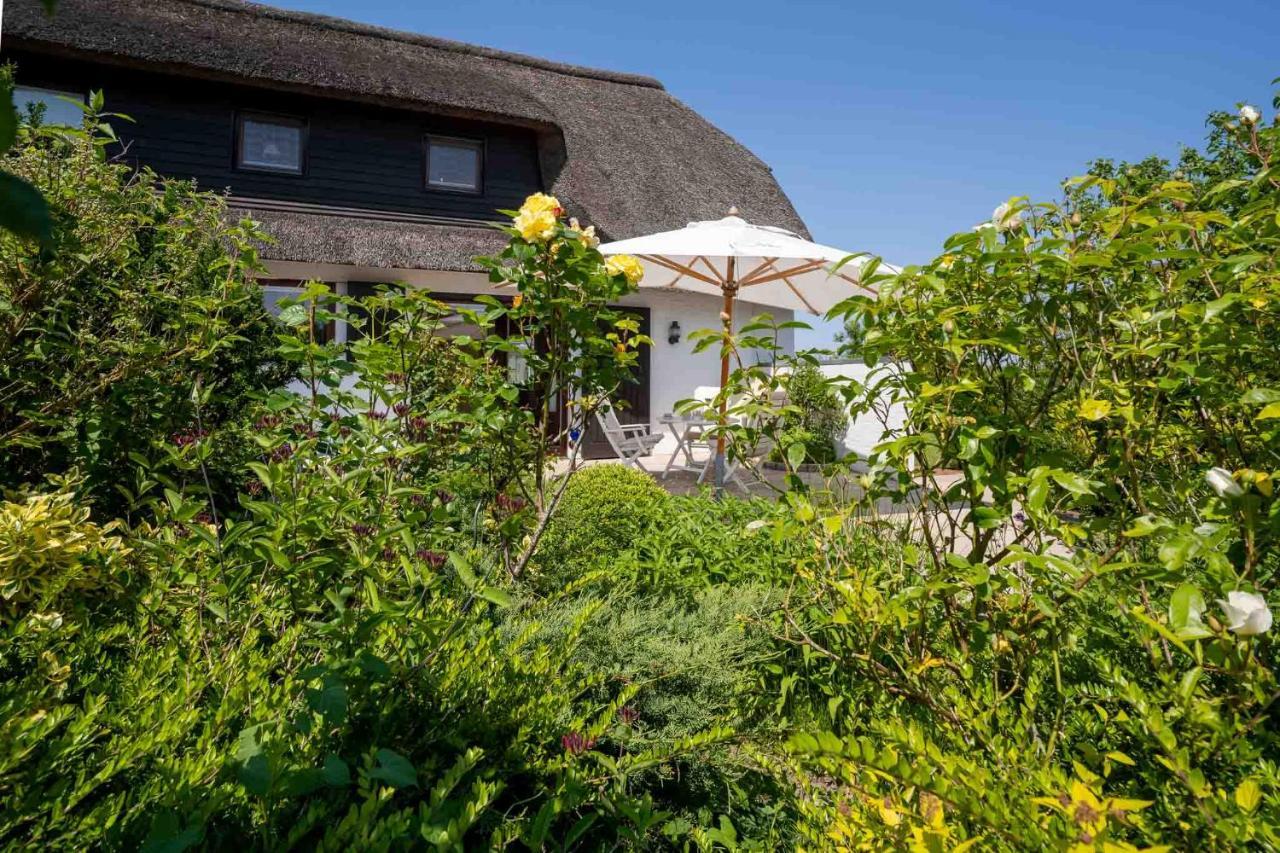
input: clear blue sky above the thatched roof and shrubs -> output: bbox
[273,0,1280,343]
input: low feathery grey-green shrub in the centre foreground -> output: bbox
[507,585,785,836]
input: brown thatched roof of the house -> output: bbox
[3,0,806,268]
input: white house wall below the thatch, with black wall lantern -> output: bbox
[268,261,795,452]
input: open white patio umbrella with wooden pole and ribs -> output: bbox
[600,207,876,494]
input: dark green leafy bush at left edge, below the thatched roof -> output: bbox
[0,97,288,511]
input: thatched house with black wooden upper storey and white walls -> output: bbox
[0,0,808,455]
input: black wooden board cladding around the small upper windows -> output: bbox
[4,51,543,220]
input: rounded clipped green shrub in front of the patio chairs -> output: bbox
[536,464,671,589]
